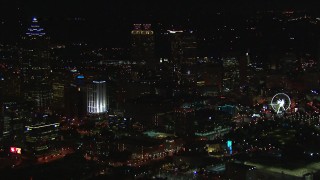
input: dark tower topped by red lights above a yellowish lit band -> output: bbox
[131,24,155,67]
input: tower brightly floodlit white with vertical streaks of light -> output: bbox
[87,81,109,114]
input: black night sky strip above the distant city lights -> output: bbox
[1,0,320,16]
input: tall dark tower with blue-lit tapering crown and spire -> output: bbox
[21,18,52,110]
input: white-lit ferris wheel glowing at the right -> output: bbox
[270,93,291,114]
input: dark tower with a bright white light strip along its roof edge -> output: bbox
[168,30,198,65]
